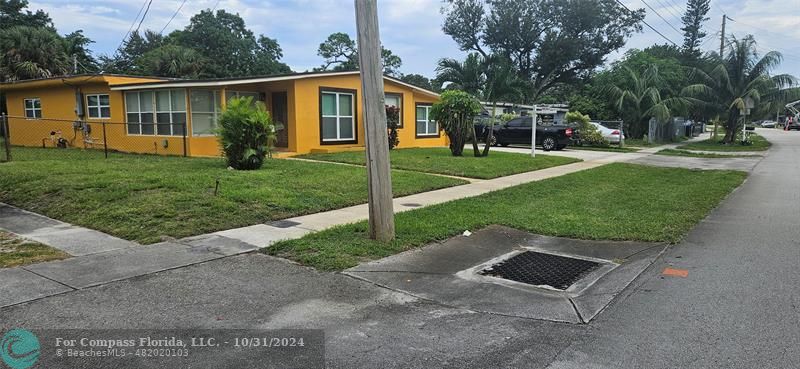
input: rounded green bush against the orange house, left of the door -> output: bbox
[217,96,275,170]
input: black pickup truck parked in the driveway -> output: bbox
[475,117,575,151]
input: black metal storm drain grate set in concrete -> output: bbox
[478,251,600,291]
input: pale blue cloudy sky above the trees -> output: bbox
[30,0,800,77]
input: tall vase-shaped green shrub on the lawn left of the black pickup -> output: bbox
[431,90,481,156]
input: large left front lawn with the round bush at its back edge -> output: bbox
[0,147,466,243]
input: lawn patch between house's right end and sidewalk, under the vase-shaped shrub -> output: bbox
[300,148,580,179]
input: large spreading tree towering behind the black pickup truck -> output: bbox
[442,0,645,101]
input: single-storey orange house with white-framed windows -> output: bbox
[0,71,447,156]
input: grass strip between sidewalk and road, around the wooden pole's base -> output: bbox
[266,164,746,270]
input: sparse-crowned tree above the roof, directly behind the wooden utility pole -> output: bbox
[317,32,403,75]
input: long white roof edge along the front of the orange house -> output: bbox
[111,70,439,97]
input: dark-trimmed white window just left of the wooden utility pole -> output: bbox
[320,90,356,142]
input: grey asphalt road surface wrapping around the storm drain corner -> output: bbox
[0,131,800,368]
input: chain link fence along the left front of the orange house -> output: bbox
[0,115,188,161]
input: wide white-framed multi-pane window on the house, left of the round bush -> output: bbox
[125,89,186,136]
